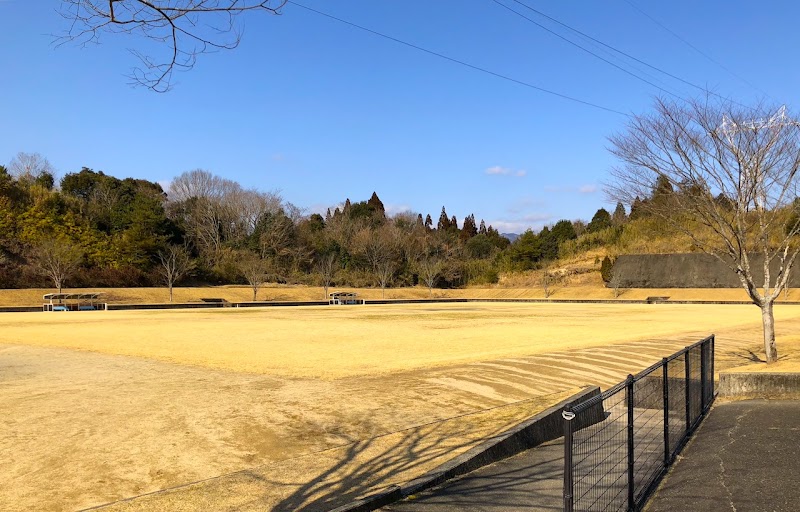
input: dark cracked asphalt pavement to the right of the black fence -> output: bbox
[645,400,800,512]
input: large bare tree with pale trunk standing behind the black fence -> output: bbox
[607,100,800,362]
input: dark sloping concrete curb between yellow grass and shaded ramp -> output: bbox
[330,387,602,512]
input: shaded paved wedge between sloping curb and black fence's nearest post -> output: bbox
[381,439,564,512]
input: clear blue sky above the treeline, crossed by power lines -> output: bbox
[0,0,800,232]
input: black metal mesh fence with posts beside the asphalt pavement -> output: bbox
[563,335,714,512]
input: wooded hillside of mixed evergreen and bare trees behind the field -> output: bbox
[0,154,688,295]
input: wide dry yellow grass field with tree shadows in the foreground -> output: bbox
[0,302,800,510]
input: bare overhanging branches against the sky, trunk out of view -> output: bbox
[57,0,286,92]
